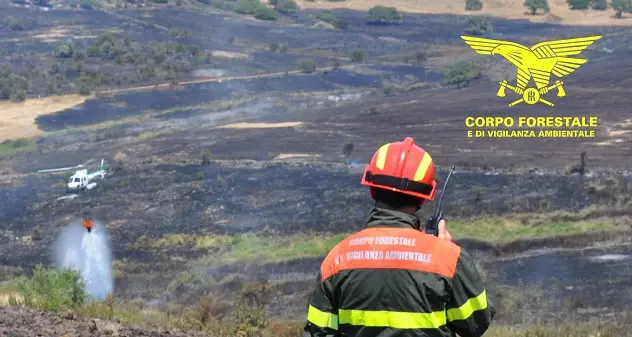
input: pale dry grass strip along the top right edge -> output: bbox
[298,0,632,26]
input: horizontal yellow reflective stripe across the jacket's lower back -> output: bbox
[338,309,446,329]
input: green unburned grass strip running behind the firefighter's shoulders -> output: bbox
[130,215,630,265]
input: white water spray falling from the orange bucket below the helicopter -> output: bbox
[54,219,114,300]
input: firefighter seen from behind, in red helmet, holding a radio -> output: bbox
[303,137,496,337]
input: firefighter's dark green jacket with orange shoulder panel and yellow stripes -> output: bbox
[303,208,496,337]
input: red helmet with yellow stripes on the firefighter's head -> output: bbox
[362,137,437,200]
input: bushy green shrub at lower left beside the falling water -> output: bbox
[18,265,87,312]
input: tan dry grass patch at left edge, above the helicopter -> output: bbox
[0,95,86,141]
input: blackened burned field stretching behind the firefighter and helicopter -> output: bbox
[0,0,632,323]
